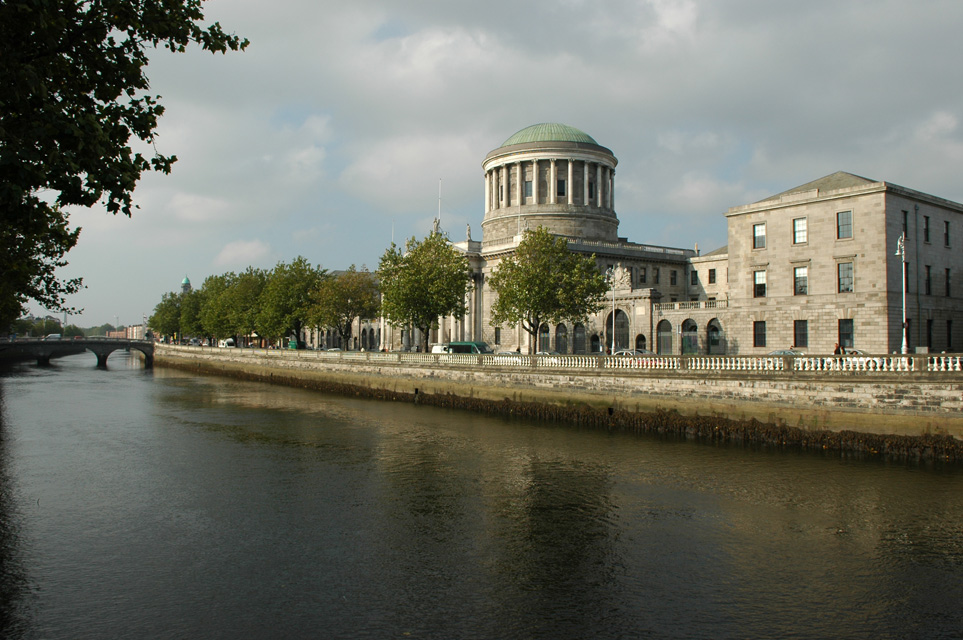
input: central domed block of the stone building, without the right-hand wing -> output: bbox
[440,123,718,353]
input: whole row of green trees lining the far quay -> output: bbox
[150,227,607,351]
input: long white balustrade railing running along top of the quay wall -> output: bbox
[163,345,963,374]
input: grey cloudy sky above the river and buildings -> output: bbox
[43,0,963,326]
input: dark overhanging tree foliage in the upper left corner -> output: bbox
[0,0,248,326]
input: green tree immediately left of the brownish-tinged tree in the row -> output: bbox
[257,256,327,342]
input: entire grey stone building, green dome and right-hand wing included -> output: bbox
[359,124,963,354]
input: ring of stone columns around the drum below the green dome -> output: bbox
[485,158,615,213]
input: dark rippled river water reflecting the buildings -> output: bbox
[0,353,963,639]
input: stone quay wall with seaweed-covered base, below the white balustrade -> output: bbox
[155,345,963,461]
